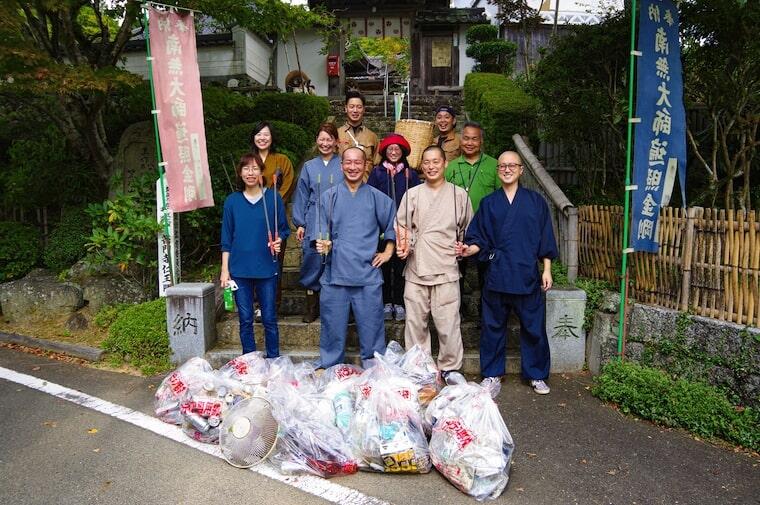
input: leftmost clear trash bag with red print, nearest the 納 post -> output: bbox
[153,358,213,424]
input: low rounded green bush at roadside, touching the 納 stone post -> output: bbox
[103,298,171,373]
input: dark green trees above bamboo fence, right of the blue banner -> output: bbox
[681,0,760,209]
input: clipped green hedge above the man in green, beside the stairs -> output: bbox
[464,73,537,157]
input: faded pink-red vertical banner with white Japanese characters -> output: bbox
[149,8,214,212]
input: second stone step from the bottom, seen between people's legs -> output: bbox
[216,312,520,352]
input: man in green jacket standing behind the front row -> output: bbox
[446,121,501,311]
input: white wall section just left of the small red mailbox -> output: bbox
[275,31,328,96]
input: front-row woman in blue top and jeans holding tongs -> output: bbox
[220,153,290,358]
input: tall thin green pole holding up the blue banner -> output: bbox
[618,0,638,360]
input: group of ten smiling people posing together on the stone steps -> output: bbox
[221,92,557,394]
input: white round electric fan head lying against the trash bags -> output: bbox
[219,396,278,468]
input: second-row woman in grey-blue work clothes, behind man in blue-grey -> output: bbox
[293,123,343,323]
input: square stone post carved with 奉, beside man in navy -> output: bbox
[546,287,586,373]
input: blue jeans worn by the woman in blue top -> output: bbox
[232,276,280,358]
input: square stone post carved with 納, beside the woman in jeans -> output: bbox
[166,282,216,364]
